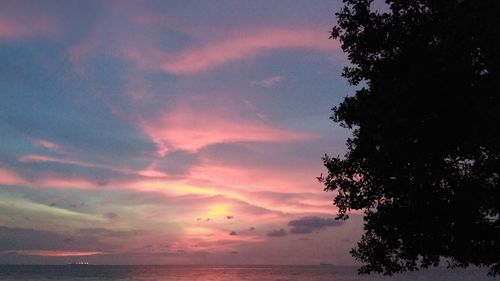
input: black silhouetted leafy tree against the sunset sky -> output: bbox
[320,0,500,274]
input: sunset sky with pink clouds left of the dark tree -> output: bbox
[0,0,362,265]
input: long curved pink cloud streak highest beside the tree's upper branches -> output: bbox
[162,27,338,75]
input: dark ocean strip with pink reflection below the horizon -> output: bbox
[0,265,500,281]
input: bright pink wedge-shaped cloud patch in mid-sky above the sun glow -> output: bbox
[139,100,310,155]
